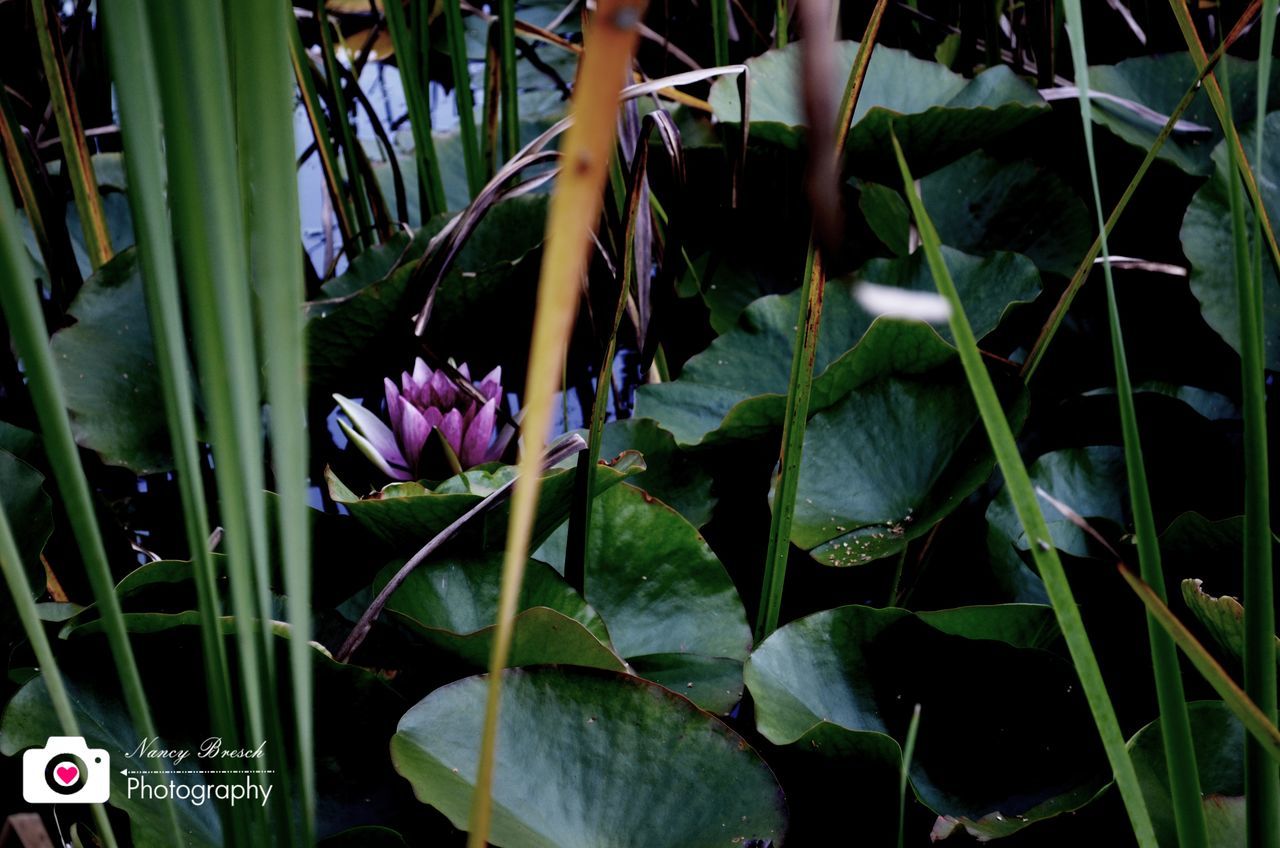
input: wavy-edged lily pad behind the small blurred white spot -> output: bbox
[636,250,1039,444]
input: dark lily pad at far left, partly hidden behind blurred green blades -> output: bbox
[51,250,173,474]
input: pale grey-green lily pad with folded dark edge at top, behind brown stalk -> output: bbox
[710,41,1048,175]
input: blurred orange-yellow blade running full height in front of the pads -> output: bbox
[467,0,644,848]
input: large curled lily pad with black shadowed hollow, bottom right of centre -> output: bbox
[746,606,1106,839]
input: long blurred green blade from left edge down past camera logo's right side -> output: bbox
[0,119,178,835]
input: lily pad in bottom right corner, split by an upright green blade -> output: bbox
[1129,701,1245,848]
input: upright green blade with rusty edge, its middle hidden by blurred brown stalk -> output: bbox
[755,0,887,643]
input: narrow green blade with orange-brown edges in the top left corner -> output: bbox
[31,0,113,270]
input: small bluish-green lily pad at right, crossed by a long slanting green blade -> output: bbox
[987,444,1129,556]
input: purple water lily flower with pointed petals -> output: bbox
[333,357,502,480]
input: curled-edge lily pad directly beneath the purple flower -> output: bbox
[325,451,645,555]
